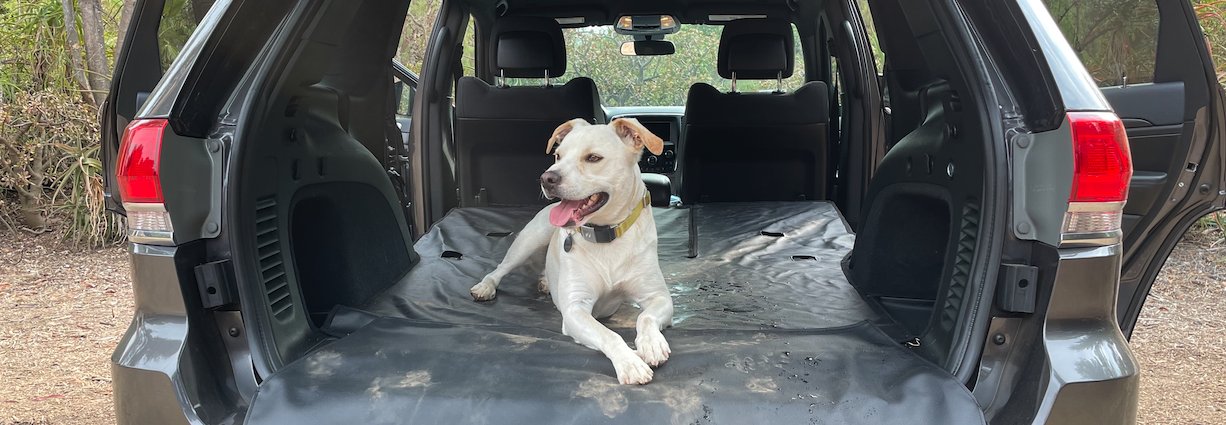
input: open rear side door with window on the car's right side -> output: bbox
[1046,0,1226,334]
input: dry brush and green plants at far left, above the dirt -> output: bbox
[0,0,121,246]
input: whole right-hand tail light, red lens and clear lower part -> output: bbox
[1062,113,1133,245]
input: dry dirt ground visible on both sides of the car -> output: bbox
[0,230,1226,425]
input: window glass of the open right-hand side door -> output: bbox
[1043,0,1159,87]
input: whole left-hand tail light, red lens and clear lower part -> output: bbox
[115,119,174,245]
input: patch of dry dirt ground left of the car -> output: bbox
[0,234,132,425]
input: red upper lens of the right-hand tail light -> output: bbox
[1069,113,1133,202]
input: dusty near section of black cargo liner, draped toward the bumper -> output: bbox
[248,318,983,424]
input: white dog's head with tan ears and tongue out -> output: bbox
[541,118,664,227]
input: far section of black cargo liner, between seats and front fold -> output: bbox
[364,202,879,329]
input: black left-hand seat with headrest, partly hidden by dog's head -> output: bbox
[455,16,604,207]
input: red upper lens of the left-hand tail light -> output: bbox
[115,119,167,203]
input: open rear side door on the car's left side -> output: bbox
[101,0,217,214]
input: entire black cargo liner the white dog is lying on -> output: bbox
[249,202,983,424]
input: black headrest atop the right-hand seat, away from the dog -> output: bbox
[717,18,796,80]
